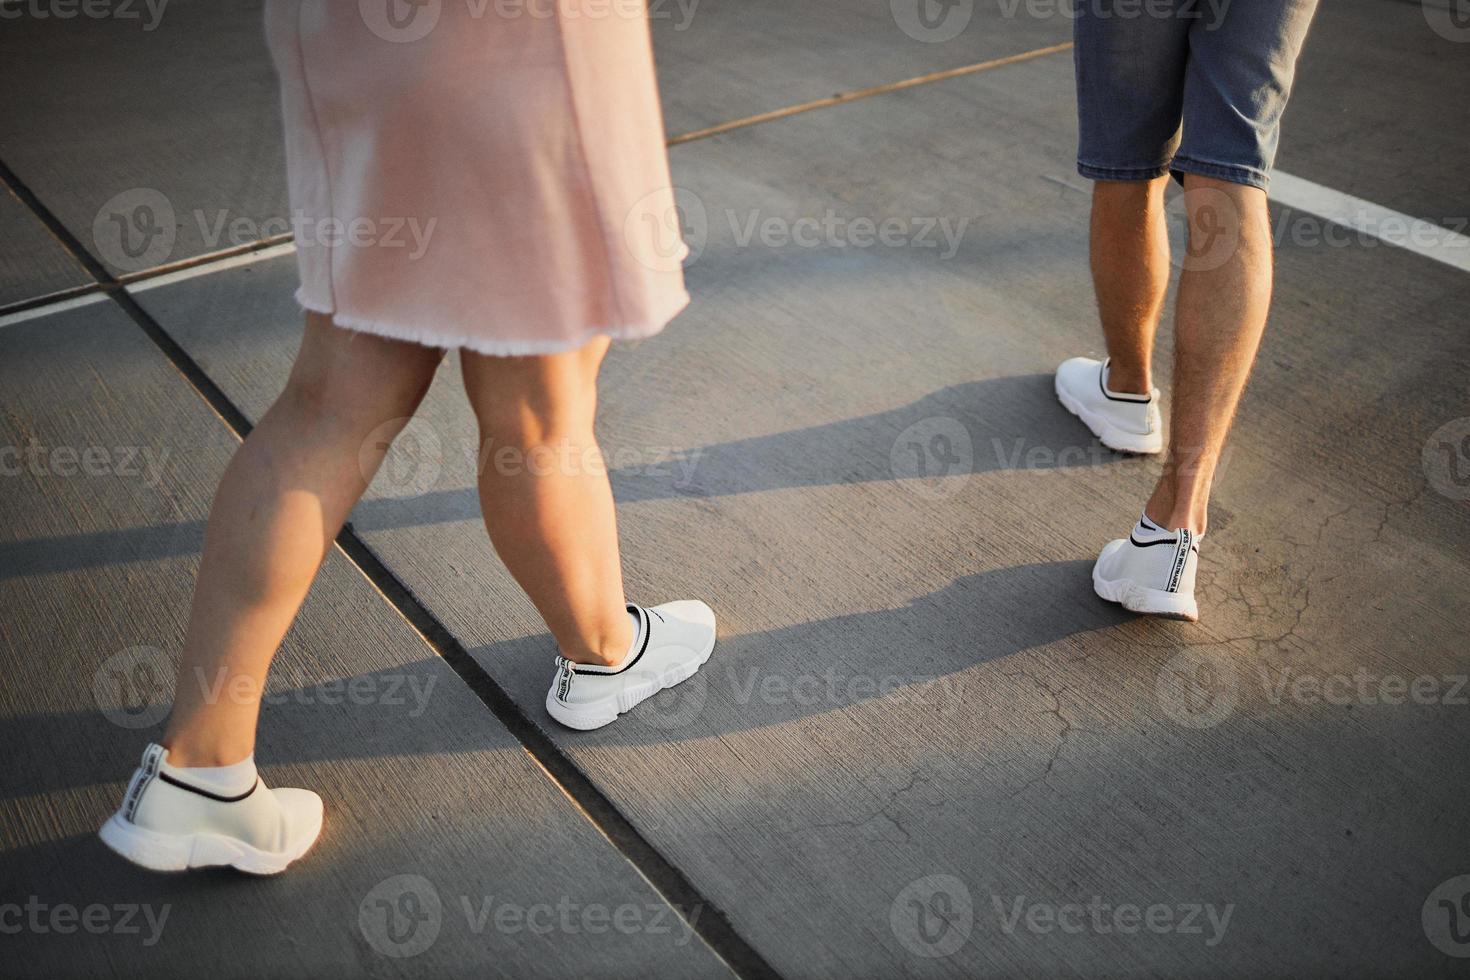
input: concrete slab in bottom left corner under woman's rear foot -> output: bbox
[0,304,728,977]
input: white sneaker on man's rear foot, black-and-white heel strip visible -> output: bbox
[1092,522,1200,623]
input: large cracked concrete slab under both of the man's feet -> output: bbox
[135,47,1470,976]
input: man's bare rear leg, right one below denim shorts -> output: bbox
[1146,173,1272,535]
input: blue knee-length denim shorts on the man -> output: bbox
[1073,0,1317,190]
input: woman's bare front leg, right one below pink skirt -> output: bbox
[462,338,632,664]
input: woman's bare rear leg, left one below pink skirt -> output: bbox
[163,313,444,767]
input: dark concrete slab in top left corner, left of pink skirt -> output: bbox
[0,0,290,275]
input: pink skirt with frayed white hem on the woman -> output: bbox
[266,0,689,354]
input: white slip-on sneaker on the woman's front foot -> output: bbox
[547,599,714,732]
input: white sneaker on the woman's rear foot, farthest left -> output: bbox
[98,745,322,874]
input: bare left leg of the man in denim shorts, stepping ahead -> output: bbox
[1091,176,1169,395]
